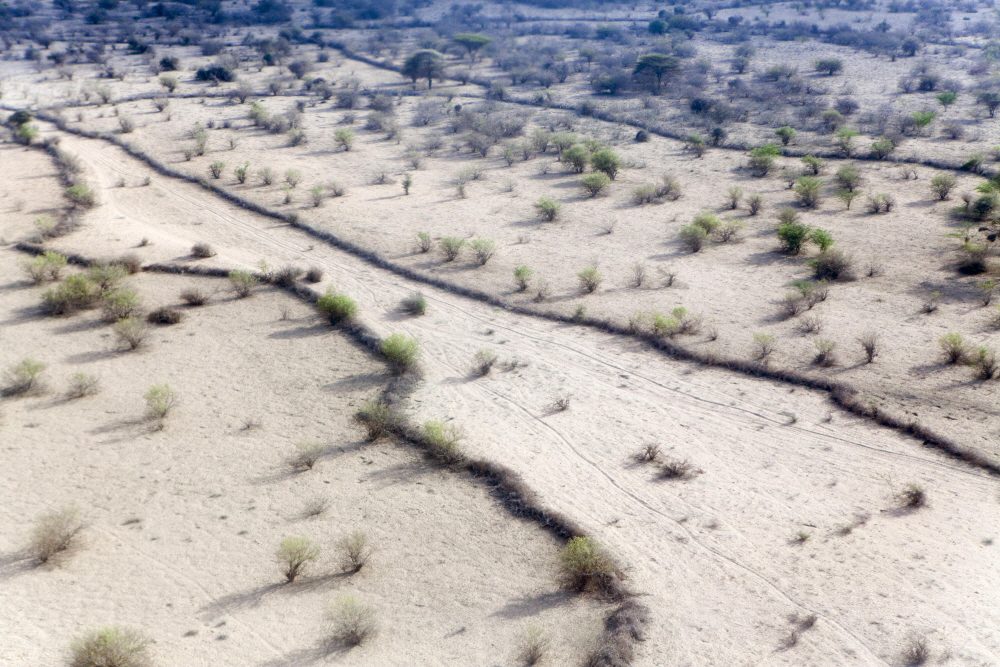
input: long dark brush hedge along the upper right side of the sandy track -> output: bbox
[21,112,1000,476]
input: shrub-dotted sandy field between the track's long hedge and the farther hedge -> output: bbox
[58,91,1000,468]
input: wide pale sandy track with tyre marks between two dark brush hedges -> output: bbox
[1,124,1000,665]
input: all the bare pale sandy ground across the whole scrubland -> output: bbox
[0,3,1000,667]
